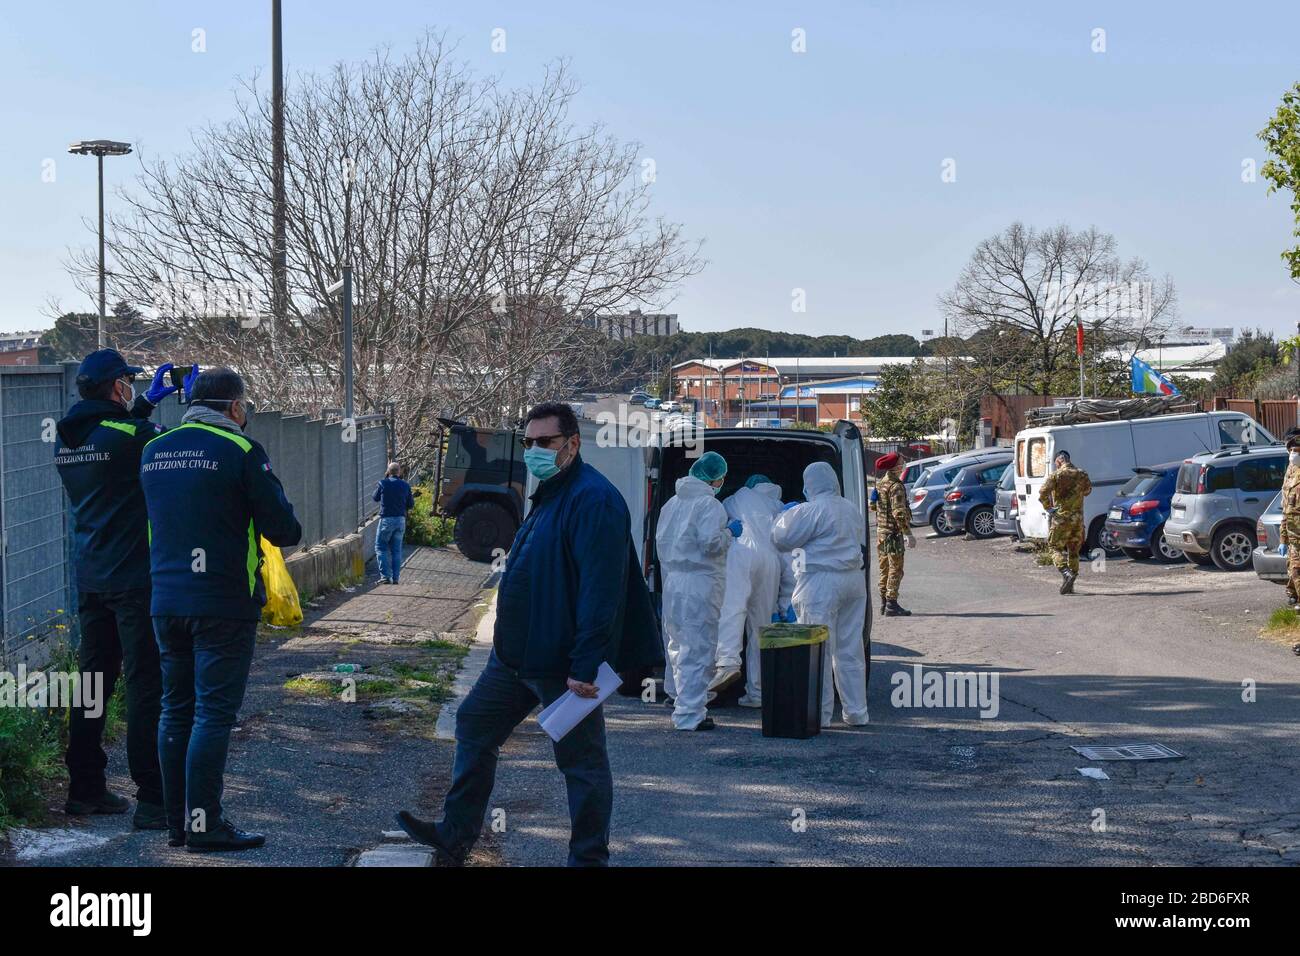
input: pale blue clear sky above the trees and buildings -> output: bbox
[0,0,1300,337]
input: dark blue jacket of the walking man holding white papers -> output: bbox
[493,458,663,683]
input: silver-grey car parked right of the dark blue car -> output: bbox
[1165,445,1287,571]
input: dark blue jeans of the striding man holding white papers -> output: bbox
[437,650,614,866]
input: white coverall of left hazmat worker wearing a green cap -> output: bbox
[655,475,732,730]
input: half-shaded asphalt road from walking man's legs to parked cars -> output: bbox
[478,538,1300,865]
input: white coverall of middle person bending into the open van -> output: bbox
[718,483,781,700]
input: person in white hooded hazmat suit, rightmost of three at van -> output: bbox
[772,462,867,727]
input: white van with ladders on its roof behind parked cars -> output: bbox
[1015,411,1275,551]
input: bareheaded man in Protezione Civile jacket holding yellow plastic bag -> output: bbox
[140,368,303,852]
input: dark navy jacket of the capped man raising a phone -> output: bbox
[55,398,163,593]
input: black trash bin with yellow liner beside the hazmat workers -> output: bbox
[758,624,829,740]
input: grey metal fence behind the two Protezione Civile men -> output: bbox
[0,363,389,667]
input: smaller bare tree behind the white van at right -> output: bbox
[939,222,1177,395]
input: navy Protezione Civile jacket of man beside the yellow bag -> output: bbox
[140,421,303,620]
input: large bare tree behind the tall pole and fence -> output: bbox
[69,35,702,468]
